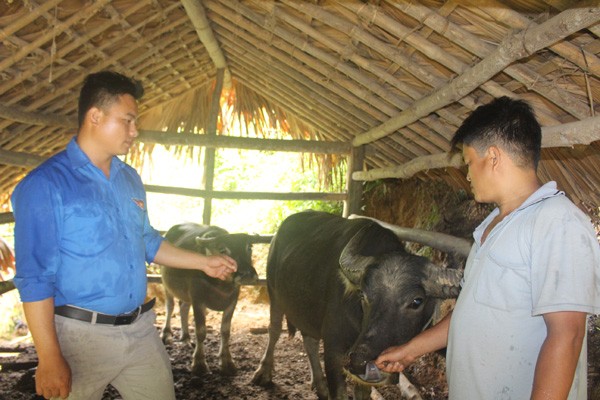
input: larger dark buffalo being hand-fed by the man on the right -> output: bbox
[252,211,460,399]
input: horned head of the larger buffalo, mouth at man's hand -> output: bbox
[340,226,462,384]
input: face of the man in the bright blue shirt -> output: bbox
[97,94,138,156]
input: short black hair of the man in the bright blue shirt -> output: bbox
[78,71,144,128]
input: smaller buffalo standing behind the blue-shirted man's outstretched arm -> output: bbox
[161,223,270,375]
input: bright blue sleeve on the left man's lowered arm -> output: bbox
[11,173,61,302]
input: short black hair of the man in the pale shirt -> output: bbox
[450,96,542,169]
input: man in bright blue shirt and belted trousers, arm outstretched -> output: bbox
[12,71,237,400]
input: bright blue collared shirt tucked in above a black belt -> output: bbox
[11,138,163,314]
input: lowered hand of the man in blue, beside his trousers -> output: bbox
[35,356,71,399]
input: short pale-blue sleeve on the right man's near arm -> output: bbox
[531,203,600,315]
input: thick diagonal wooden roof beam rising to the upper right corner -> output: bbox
[352,7,600,146]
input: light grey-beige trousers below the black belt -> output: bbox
[55,311,175,400]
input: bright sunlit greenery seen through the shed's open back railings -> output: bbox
[142,149,345,234]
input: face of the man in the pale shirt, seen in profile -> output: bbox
[463,145,494,203]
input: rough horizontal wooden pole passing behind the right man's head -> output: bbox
[352,116,600,181]
